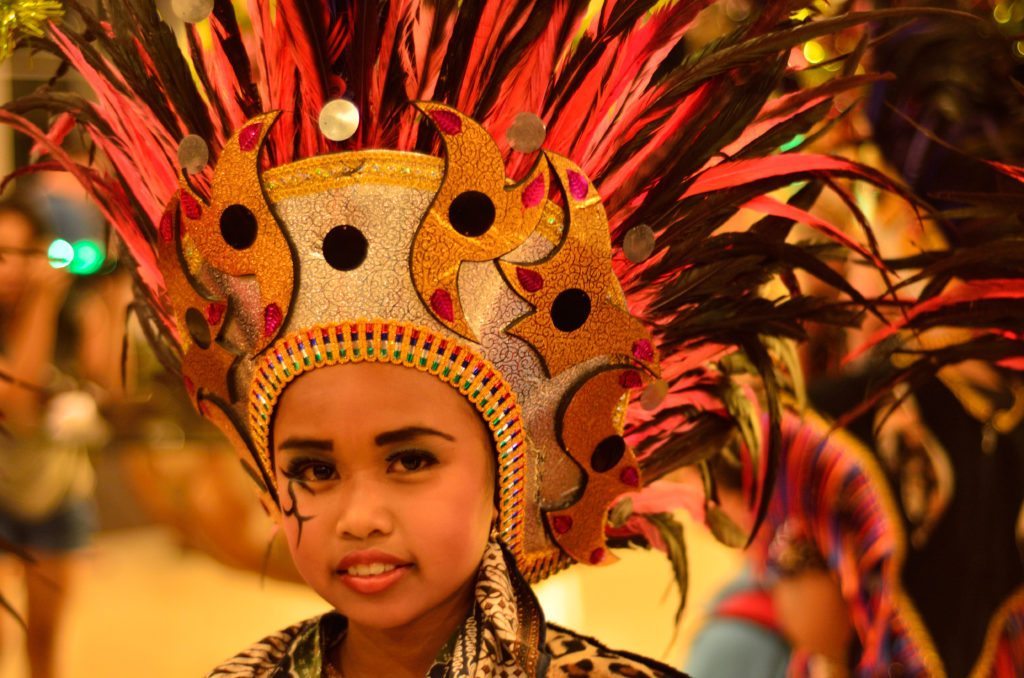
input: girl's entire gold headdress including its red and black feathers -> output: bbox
[0,0,909,580]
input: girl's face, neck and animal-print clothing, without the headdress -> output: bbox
[210,363,681,677]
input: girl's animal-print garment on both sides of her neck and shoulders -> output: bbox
[208,542,683,678]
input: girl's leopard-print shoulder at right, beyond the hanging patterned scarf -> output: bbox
[546,623,686,678]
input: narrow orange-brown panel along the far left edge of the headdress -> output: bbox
[157,200,236,414]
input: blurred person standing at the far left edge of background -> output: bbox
[0,200,103,678]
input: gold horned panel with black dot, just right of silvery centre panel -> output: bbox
[410,102,550,341]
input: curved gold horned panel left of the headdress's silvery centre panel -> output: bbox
[181,112,295,351]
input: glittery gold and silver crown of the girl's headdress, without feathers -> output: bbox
[158,103,658,578]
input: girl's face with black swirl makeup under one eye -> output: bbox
[272,363,496,629]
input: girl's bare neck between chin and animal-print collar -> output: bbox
[329,580,475,678]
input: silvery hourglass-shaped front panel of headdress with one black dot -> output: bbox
[264,152,443,331]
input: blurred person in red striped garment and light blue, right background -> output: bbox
[686,413,937,678]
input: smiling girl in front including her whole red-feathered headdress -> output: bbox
[0,0,905,678]
